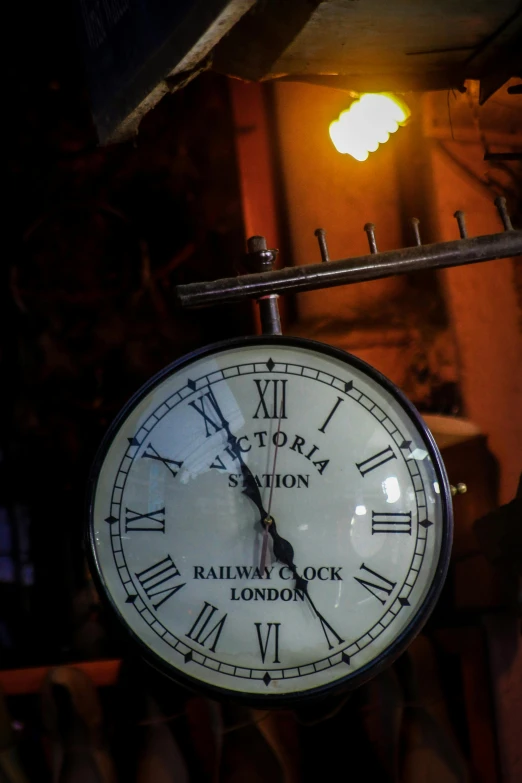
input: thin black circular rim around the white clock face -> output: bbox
[85,335,453,709]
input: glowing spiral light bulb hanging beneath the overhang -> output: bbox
[330,93,410,161]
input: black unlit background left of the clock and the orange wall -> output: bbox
[0,3,252,668]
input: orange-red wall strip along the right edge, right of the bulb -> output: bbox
[431,142,522,502]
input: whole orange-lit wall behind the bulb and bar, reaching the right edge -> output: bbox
[274,83,522,502]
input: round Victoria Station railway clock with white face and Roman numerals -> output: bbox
[89,337,451,704]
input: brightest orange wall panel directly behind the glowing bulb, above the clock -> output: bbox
[275,83,403,321]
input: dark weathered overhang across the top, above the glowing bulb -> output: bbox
[76,0,522,143]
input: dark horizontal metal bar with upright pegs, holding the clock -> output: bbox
[176,231,522,307]
